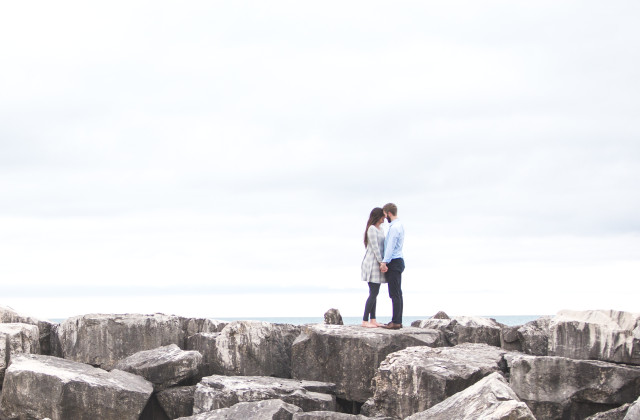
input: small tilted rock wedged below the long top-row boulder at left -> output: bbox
[115,344,202,391]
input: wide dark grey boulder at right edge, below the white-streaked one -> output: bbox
[510,356,640,419]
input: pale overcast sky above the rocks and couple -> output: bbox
[0,0,640,318]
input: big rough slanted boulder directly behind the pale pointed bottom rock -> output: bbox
[362,343,507,418]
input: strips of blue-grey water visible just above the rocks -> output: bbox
[50,315,542,326]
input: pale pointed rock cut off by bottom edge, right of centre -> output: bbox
[407,373,536,420]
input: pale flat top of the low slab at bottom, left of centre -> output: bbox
[200,375,335,394]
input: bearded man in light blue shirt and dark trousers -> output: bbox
[380,203,404,330]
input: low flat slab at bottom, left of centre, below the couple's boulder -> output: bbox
[193,375,336,414]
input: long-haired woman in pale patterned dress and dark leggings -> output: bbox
[362,207,387,328]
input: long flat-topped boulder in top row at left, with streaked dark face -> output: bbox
[56,314,218,370]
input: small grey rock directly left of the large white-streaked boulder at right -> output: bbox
[500,317,551,356]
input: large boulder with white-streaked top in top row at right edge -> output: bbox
[549,310,640,365]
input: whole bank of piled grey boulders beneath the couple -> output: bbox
[0,306,640,420]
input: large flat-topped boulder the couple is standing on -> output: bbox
[292,324,444,402]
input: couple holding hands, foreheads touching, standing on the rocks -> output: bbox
[362,203,404,330]
